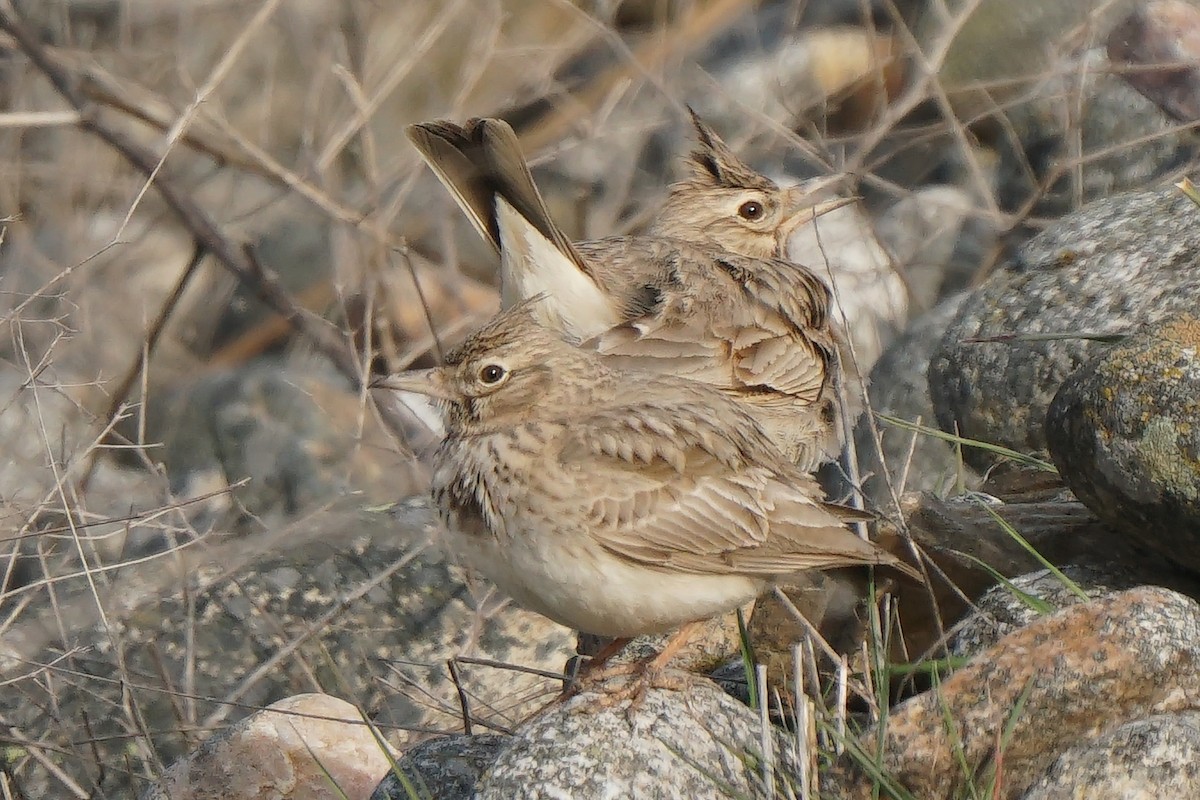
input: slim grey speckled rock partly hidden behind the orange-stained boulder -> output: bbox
[948,566,1139,657]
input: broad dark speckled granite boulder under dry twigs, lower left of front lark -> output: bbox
[0,498,574,796]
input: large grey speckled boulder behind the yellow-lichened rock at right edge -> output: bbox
[929,188,1200,467]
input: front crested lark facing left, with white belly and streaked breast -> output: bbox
[376,300,907,664]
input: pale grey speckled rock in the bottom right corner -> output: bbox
[1021,711,1200,800]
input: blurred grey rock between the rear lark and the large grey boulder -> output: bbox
[854,294,978,510]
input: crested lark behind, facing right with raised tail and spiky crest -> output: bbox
[408,112,845,470]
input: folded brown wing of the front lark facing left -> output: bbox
[559,403,895,578]
